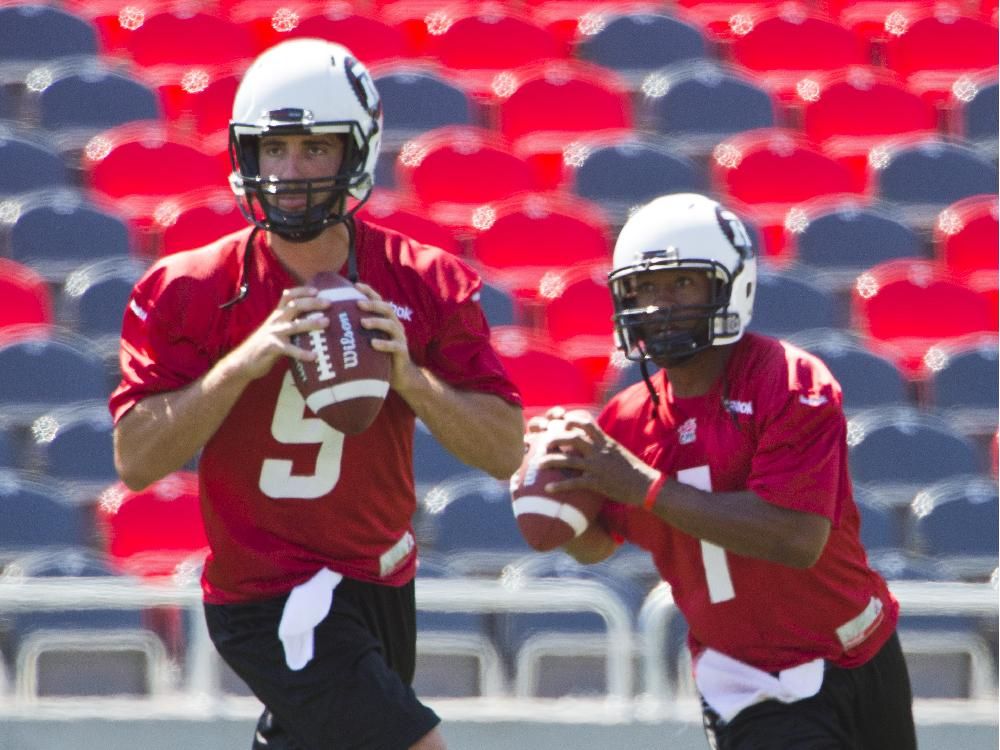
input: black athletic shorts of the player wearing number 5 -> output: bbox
[205,578,440,750]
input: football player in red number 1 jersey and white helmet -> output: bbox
[529,194,916,750]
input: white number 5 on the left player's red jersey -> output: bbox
[259,372,344,500]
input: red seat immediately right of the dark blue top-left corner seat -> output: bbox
[103,6,258,69]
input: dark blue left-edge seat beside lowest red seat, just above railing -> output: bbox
[0,471,93,564]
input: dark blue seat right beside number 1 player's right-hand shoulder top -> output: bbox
[788,328,914,414]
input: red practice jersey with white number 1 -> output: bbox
[599,334,899,672]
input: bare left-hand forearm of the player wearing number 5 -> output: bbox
[114,360,249,490]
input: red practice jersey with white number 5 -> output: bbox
[110,221,519,604]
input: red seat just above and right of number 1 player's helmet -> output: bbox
[710,128,863,260]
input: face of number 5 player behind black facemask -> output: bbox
[258,134,344,213]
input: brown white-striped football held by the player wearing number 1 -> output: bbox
[510,419,604,552]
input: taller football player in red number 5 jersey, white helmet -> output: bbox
[110,39,524,750]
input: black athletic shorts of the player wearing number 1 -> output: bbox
[702,633,917,750]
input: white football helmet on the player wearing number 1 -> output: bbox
[608,193,757,365]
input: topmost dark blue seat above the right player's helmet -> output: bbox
[576,11,708,88]
